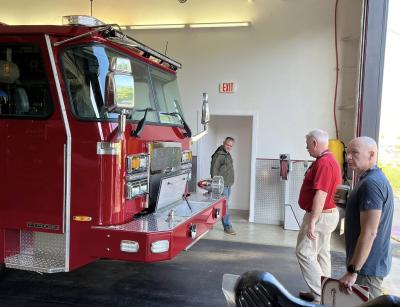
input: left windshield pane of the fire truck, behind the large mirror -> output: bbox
[62,45,158,122]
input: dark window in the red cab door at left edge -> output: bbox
[0,44,52,118]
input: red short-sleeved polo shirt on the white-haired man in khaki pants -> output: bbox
[299,151,342,212]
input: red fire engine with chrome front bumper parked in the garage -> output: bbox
[0,16,226,273]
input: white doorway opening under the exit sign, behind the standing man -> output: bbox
[198,114,255,220]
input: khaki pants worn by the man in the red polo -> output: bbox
[296,210,339,296]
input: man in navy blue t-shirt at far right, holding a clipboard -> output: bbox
[340,137,394,298]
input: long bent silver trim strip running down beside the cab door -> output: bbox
[44,34,72,272]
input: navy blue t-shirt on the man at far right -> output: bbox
[345,166,394,277]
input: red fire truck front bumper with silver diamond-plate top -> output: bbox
[91,193,226,262]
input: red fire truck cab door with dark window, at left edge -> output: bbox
[0,35,66,233]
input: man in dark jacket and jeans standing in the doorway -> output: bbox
[210,136,236,235]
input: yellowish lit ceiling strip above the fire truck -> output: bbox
[0,0,256,25]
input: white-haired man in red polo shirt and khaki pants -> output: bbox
[296,130,341,302]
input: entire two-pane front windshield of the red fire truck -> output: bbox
[61,45,183,125]
